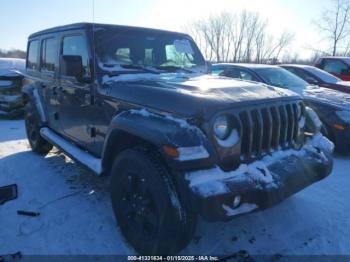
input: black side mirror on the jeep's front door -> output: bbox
[60,55,84,81]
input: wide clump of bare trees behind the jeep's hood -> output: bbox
[184,10,294,62]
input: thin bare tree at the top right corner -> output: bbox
[316,0,350,56]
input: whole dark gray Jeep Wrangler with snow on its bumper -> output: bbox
[23,23,333,254]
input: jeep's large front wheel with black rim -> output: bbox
[111,149,197,255]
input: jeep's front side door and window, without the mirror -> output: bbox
[58,31,95,149]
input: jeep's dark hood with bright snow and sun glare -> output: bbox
[102,73,299,118]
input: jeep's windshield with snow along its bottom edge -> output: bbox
[95,29,205,71]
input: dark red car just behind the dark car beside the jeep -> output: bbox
[279,65,350,94]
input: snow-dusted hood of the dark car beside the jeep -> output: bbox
[303,86,350,110]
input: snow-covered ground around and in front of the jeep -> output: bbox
[0,121,350,255]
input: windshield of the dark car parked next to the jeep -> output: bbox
[255,67,308,92]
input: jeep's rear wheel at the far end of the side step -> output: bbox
[24,102,52,155]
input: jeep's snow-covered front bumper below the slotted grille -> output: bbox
[186,135,333,221]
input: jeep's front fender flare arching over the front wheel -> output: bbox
[102,110,216,173]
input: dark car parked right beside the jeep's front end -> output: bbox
[212,64,350,154]
